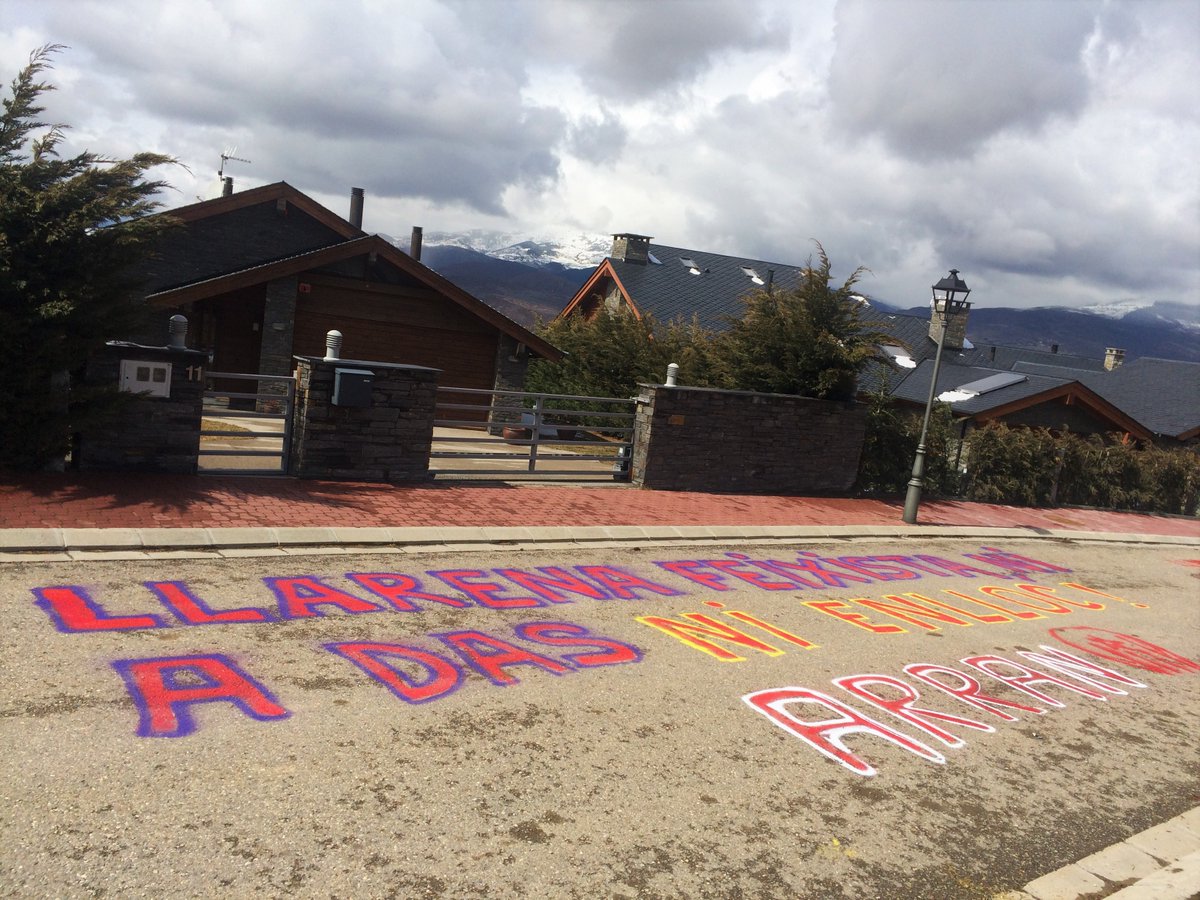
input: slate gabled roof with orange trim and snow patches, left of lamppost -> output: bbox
[559,244,803,331]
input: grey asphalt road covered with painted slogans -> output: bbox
[0,539,1200,900]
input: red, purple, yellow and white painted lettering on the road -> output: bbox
[21,547,1200,775]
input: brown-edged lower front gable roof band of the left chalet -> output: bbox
[146,234,563,360]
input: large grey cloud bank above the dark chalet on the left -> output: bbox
[22,4,568,214]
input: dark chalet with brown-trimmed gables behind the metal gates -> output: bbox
[138,181,562,390]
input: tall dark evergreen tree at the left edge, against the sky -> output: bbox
[0,44,173,469]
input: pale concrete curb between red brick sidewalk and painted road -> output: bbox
[0,524,1200,562]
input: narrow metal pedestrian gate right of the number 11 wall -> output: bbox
[199,372,296,475]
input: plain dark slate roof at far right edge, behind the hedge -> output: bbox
[1084,356,1200,440]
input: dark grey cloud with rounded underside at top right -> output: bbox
[829,0,1099,158]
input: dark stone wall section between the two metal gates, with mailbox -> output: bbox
[289,356,439,482]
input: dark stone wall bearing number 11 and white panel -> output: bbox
[76,341,208,474]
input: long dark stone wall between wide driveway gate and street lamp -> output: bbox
[632,384,866,493]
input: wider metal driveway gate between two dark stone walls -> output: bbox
[430,388,635,481]
